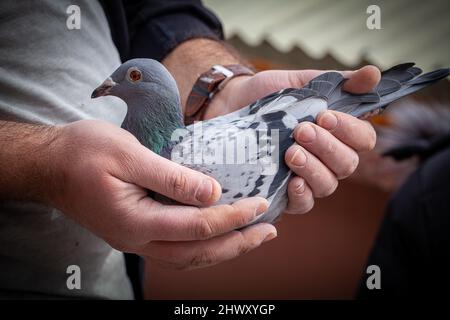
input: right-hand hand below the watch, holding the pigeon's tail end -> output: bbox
[205,66,380,213]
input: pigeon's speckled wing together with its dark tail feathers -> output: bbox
[167,64,450,222]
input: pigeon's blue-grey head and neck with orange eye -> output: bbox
[91,59,183,153]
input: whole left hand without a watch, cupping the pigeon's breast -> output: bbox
[48,120,276,269]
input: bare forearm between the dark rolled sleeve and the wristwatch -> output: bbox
[163,39,246,107]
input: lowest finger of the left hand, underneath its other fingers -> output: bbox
[138,223,277,269]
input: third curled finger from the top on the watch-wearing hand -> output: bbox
[285,144,338,198]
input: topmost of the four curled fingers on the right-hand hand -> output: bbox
[317,110,377,152]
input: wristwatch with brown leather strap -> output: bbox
[184,64,255,125]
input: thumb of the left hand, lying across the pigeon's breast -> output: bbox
[116,145,222,206]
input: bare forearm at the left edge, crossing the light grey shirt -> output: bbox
[0,121,58,202]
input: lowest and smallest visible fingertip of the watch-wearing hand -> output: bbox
[285,176,314,214]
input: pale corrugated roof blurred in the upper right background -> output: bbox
[204,0,450,70]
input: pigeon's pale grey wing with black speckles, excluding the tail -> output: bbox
[171,96,327,222]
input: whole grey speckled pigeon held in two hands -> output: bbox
[92,59,450,225]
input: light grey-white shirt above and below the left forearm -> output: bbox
[0,0,132,299]
